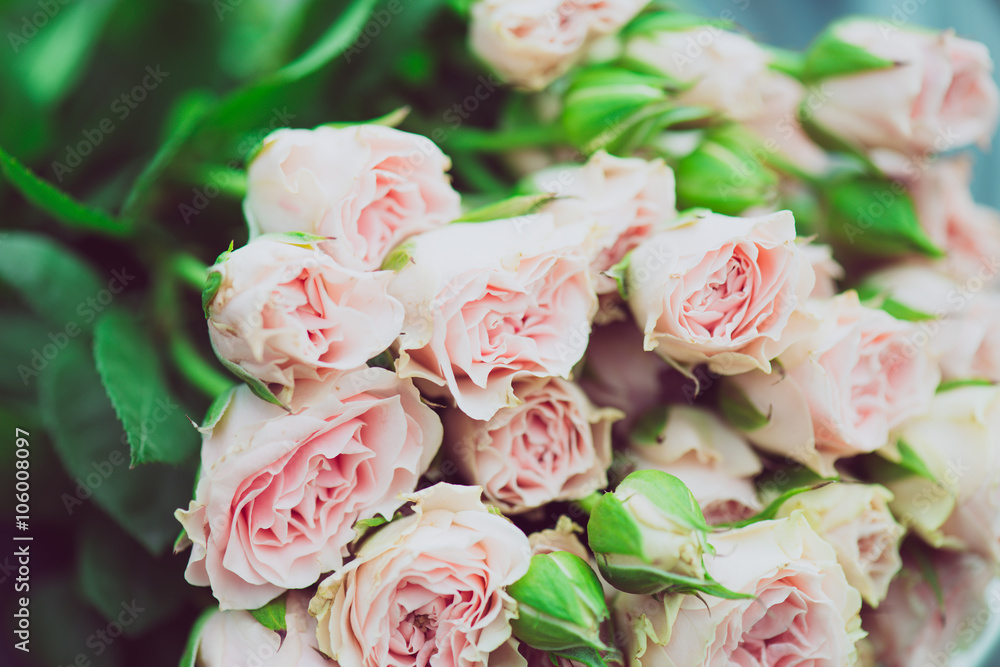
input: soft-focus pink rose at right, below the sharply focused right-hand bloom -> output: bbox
[729,291,941,477]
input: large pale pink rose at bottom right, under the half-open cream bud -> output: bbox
[614,514,864,667]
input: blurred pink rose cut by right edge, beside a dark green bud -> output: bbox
[909,156,1000,289]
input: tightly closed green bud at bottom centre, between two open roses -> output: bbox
[507,551,617,664]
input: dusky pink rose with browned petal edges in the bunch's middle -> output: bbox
[444,377,619,514]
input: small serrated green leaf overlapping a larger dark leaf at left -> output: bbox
[94,311,200,466]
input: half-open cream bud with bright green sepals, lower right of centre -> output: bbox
[587,470,744,596]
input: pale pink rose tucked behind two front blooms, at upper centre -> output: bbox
[531,151,677,294]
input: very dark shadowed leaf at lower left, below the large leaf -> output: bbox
[77,518,185,636]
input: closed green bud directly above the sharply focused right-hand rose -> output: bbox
[674,125,778,215]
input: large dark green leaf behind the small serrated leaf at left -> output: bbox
[38,341,194,554]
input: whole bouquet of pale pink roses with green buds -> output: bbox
[3,0,1000,667]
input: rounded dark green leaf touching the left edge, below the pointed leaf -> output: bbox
[0,232,104,330]
